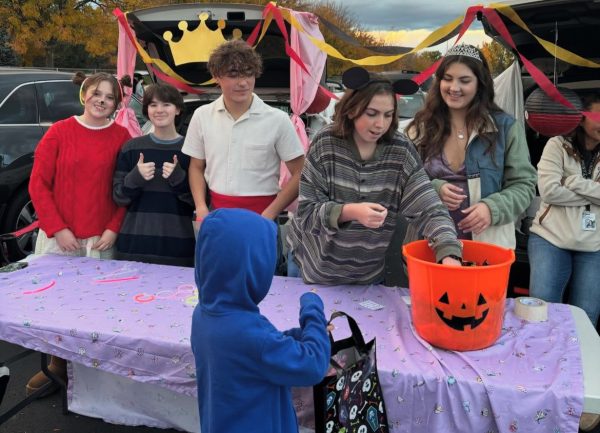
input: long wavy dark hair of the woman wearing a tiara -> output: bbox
[407,47,502,161]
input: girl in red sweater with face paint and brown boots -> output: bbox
[26,73,131,394]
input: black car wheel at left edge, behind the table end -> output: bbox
[0,188,38,262]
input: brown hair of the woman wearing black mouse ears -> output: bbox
[332,79,398,141]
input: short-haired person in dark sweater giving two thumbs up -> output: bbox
[113,84,195,267]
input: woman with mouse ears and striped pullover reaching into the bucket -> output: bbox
[287,68,462,284]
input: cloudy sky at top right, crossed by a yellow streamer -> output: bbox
[328,0,491,48]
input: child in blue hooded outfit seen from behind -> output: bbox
[192,209,330,433]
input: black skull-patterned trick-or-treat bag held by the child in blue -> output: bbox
[313,311,389,433]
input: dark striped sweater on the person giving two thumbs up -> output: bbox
[113,135,195,266]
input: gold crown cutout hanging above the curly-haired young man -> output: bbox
[163,12,242,66]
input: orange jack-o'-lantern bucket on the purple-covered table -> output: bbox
[402,240,515,350]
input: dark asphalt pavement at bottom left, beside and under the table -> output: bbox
[0,341,179,433]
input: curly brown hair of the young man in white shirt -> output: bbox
[207,39,262,78]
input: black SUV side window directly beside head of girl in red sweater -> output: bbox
[36,81,83,123]
